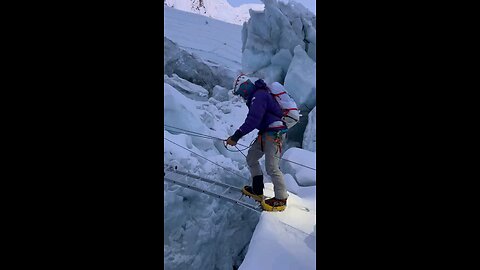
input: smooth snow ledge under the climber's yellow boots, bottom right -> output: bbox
[239,183,316,270]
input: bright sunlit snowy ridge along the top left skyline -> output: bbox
[163,0,264,25]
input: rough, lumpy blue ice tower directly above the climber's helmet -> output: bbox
[242,0,316,82]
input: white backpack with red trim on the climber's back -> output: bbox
[268,82,302,129]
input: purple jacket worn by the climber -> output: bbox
[232,84,285,141]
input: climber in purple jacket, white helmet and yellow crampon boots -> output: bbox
[227,74,288,211]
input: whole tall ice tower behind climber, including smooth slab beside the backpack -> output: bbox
[242,0,316,146]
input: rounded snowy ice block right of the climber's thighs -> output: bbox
[280,147,317,186]
